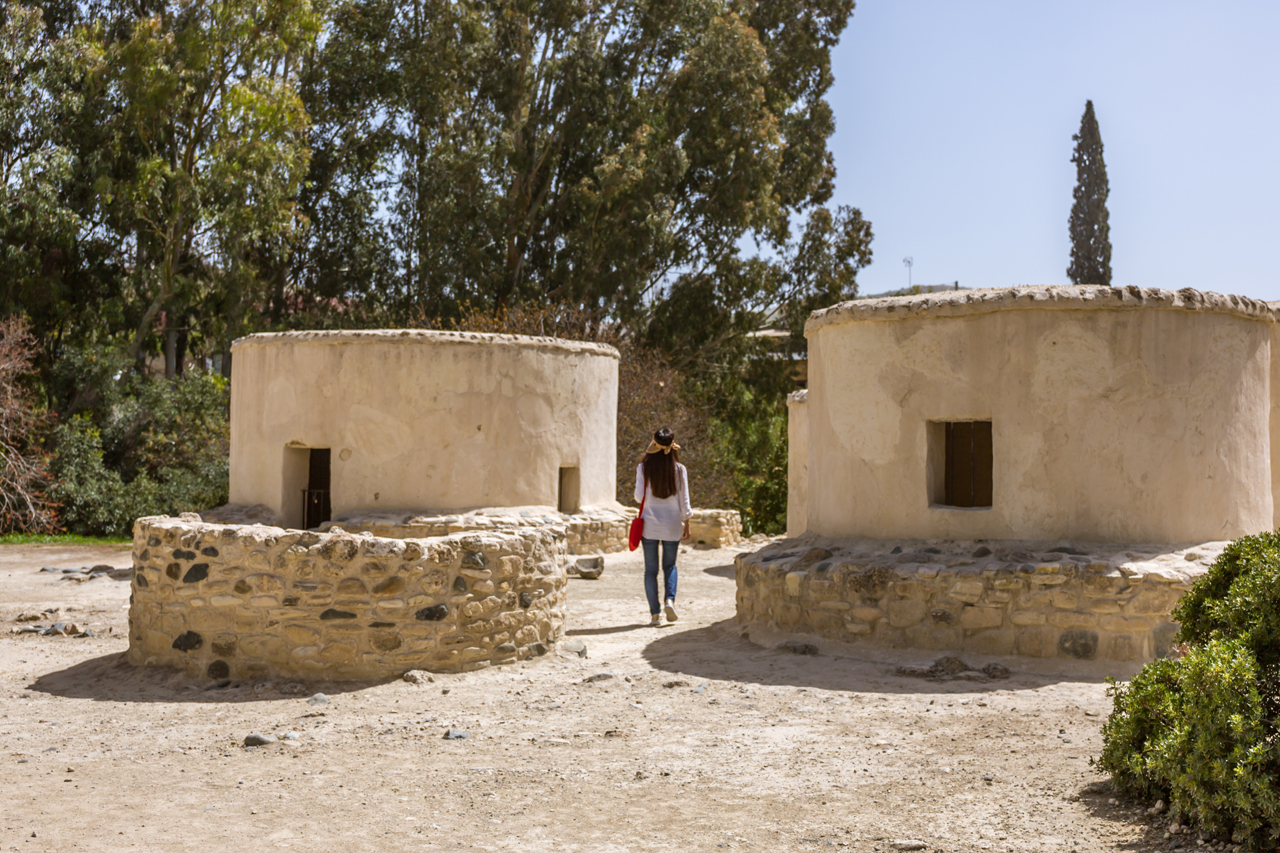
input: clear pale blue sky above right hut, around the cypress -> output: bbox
[829,0,1280,300]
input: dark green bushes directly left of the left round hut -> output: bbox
[50,351,229,535]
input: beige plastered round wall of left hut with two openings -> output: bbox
[230,330,618,528]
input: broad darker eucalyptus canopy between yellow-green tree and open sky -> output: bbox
[298,0,852,327]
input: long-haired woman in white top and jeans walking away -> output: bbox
[636,427,694,625]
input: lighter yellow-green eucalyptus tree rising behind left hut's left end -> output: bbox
[101,0,319,359]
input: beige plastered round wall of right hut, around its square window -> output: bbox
[805,287,1275,542]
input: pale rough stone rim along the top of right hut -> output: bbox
[805,284,1276,334]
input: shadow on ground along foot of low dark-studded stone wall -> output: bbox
[26,652,384,703]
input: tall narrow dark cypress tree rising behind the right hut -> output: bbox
[1066,101,1111,286]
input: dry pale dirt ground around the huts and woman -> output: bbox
[0,546,1197,853]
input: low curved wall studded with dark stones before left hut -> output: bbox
[128,515,566,680]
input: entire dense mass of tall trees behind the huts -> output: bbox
[0,0,872,529]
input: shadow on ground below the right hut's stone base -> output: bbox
[641,620,1123,694]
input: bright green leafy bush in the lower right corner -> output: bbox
[1097,533,1280,848]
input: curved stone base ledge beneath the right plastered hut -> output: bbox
[735,537,1228,661]
